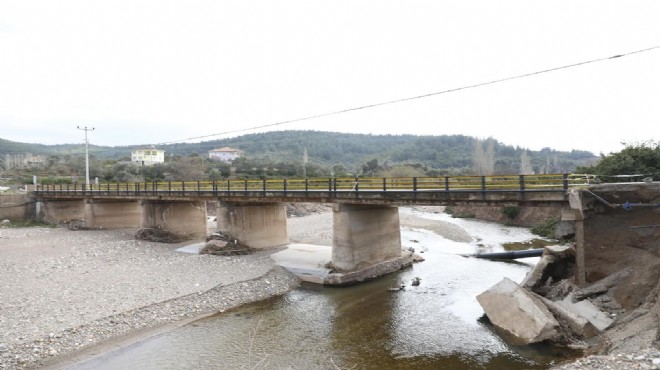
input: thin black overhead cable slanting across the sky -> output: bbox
[154,45,660,145]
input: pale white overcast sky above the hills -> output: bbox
[0,0,660,154]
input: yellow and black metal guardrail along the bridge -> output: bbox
[35,174,595,196]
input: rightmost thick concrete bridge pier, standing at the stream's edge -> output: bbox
[332,204,401,271]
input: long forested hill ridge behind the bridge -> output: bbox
[0,131,598,173]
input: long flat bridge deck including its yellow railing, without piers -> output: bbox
[34,174,589,205]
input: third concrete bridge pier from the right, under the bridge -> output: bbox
[140,200,208,237]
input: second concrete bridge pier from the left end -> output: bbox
[85,199,141,229]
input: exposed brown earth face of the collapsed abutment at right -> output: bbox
[569,183,660,308]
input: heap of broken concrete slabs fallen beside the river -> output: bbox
[477,245,656,349]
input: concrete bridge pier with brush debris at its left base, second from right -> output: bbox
[217,202,289,249]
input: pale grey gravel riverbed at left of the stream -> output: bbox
[0,228,299,369]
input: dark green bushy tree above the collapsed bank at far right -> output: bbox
[576,140,660,182]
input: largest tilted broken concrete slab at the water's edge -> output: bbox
[477,278,560,344]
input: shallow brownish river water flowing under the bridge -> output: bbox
[64,209,576,370]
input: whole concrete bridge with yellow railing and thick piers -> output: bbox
[33,174,660,284]
